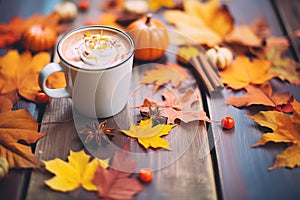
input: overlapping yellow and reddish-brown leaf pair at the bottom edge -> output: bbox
[44,150,145,199]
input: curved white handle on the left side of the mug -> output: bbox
[38,63,71,98]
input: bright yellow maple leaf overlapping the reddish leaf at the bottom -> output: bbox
[44,150,109,192]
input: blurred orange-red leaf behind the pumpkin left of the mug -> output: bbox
[0,13,66,48]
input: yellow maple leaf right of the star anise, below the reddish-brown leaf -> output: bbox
[120,119,176,150]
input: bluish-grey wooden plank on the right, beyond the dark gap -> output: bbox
[207,0,300,200]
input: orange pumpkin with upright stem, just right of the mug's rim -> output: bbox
[127,14,169,61]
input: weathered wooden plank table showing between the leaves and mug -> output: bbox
[0,0,300,200]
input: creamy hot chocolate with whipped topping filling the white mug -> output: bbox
[60,28,132,70]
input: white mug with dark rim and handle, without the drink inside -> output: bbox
[39,26,134,118]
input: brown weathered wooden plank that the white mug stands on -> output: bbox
[27,61,216,199]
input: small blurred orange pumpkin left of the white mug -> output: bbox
[21,25,57,52]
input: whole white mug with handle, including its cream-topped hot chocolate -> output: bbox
[38,25,134,118]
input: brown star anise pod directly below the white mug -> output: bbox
[79,121,115,146]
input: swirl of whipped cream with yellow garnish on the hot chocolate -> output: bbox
[75,30,126,68]
